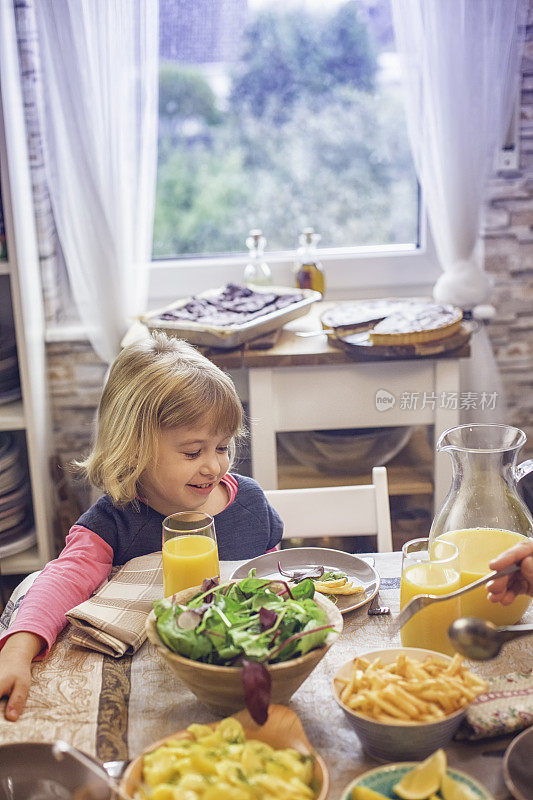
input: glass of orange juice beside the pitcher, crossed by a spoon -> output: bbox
[400,539,461,655]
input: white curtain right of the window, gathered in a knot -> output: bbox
[392,0,528,422]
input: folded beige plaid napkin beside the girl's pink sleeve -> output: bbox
[66,552,163,658]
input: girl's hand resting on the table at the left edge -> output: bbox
[0,631,44,722]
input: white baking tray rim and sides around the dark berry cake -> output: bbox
[139,286,322,350]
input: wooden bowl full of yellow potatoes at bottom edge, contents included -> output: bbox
[120,705,329,800]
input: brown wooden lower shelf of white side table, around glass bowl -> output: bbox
[278,429,433,496]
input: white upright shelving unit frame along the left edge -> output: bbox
[0,15,54,575]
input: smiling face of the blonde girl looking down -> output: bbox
[139,425,231,515]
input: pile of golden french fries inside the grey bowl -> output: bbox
[335,653,488,723]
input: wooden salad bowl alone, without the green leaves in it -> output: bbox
[146,586,343,716]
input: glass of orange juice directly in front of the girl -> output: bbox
[163,511,220,597]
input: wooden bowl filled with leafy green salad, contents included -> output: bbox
[146,578,343,724]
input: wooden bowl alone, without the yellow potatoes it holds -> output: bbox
[120,705,329,800]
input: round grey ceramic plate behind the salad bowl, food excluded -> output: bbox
[231,547,380,614]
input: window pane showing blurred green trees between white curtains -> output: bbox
[153,0,420,260]
